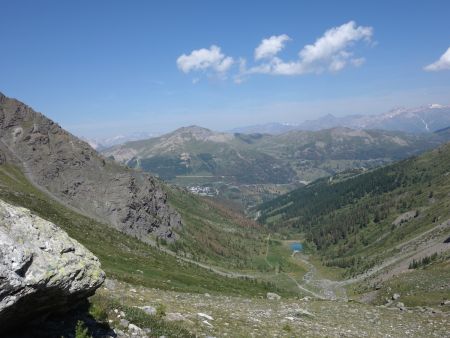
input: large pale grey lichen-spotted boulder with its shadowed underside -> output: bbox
[0,200,105,330]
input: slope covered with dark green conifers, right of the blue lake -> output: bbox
[258,145,450,275]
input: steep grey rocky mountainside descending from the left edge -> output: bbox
[0,93,181,240]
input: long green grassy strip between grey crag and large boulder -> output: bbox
[0,164,282,296]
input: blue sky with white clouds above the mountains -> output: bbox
[0,0,450,138]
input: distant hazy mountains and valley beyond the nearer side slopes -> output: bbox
[103,126,449,209]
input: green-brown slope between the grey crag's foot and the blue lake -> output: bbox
[162,186,306,294]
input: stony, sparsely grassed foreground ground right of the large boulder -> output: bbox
[99,281,450,337]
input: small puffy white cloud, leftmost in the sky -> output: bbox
[177,45,234,75]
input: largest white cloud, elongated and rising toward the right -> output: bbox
[246,21,373,75]
